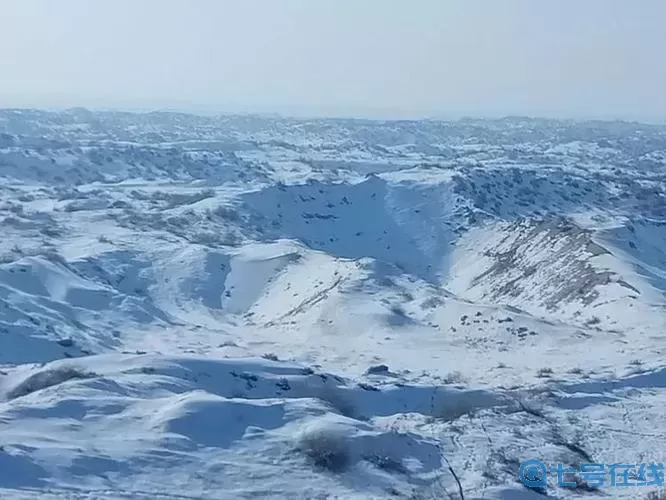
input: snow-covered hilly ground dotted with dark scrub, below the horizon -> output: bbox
[0,109,666,500]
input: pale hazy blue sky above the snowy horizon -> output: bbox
[0,0,666,121]
